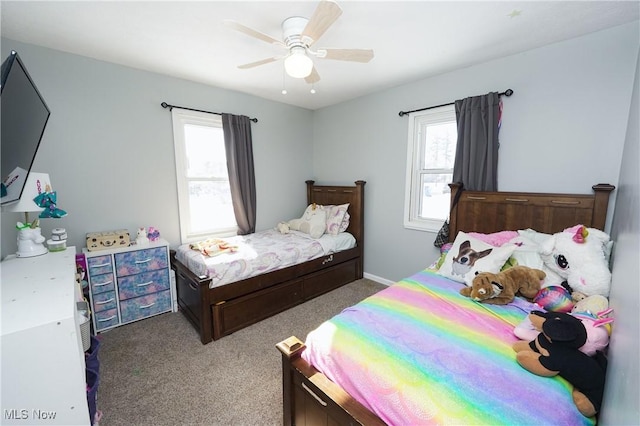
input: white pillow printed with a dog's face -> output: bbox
[438,232,515,286]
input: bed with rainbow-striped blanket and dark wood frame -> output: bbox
[277,184,614,425]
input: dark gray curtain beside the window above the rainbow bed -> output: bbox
[453,92,500,191]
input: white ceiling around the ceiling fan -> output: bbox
[0,0,640,110]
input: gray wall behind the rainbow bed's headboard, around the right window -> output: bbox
[313,21,638,281]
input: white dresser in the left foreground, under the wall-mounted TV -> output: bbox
[0,247,89,425]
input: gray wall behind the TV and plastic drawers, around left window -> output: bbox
[1,39,314,258]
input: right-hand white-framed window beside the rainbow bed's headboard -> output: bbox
[404,105,458,232]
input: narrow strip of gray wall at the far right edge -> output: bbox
[600,46,640,425]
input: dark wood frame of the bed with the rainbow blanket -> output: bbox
[276,184,615,426]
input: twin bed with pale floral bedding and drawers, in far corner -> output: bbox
[171,180,365,344]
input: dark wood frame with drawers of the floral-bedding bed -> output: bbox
[171,180,366,344]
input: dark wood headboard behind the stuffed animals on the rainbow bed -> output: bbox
[449,183,615,241]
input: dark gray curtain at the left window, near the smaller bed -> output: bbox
[222,114,256,235]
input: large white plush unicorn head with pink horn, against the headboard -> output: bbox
[539,225,611,301]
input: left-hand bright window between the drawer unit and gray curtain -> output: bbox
[171,108,238,243]
